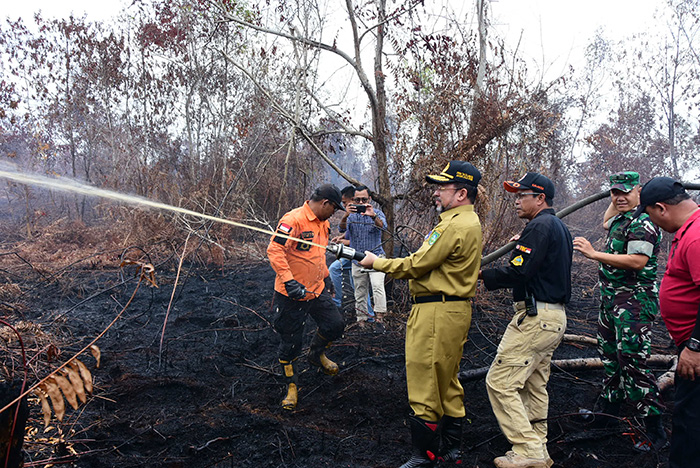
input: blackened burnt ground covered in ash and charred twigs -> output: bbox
[0,255,673,468]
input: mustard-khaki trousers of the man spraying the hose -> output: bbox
[406,299,472,421]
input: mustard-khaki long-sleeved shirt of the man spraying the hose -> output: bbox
[374,205,481,298]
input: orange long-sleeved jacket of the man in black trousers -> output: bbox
[267,201,330,301]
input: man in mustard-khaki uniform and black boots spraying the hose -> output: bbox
[360,161,481,468]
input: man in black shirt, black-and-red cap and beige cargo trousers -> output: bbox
[479,172,573,468]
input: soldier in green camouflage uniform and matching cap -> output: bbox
[574,172,666,451]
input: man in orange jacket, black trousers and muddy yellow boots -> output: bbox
[267,184,344,410]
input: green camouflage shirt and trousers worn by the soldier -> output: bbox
[598,211,663,417]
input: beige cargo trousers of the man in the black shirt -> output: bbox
[486,302,566,458]
